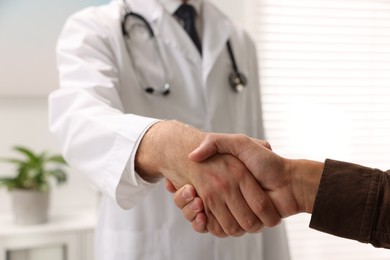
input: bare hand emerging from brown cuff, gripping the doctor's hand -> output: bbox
[168,134,323,235]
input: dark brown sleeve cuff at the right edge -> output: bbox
[310,159,390,248]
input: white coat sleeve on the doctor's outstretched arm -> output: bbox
[49,9,158,209]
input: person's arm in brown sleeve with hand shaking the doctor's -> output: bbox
[167,134,390,248]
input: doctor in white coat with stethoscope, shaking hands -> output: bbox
[49,0,289,260]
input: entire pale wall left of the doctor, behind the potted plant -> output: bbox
[0,0,109,214]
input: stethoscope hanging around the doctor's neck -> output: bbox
[122,0,247,96]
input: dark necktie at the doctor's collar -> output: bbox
[175,4,202,54]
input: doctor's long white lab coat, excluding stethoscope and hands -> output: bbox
[49,0,289,260]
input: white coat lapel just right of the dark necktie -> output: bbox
[202,1,233,85]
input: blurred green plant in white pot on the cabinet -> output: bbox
[0,146,66,225]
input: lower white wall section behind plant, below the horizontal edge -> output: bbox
[0,97,97,214]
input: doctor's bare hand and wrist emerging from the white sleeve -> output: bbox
[135,121,280,237]
